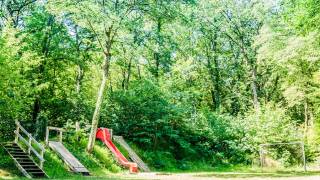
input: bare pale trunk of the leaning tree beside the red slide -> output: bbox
[87,51,111,153]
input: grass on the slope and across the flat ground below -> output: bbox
[0,137,320,180]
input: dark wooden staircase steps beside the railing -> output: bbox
[3,143,48,179]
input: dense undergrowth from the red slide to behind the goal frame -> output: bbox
[100,80,315,170]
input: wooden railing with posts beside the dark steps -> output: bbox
[14,121,45,169]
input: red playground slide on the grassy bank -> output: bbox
[96,128,138,173]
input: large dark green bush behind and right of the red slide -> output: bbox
[100,80,243,169]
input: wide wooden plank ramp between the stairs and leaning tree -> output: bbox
[48,141,89,175]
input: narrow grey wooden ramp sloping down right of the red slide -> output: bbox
[112,136,150,172]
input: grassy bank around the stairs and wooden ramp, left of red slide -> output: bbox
[0,140,121,179]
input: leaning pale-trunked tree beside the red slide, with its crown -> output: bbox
[47,0,152,152]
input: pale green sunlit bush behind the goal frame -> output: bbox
[232,104,302,164]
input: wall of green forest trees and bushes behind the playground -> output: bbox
[0,0,320,178]
